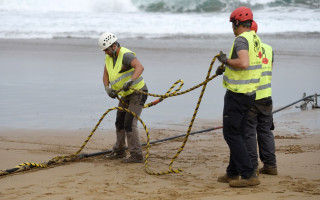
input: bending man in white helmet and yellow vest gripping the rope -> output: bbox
[99,32,148,163]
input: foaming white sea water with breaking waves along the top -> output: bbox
[0,0,320,38]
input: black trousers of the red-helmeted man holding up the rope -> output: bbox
[223,90,256,178]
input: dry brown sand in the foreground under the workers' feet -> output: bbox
[0,110,320,200]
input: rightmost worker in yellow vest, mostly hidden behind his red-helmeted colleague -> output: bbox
[246,21,278,175]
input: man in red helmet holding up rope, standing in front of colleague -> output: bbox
[216,7,262,187]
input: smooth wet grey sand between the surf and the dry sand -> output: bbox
[0,34,320,130]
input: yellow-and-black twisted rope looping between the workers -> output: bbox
[0,54,219,176]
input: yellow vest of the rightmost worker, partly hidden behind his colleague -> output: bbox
[256,43,273,100]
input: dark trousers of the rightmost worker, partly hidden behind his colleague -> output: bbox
[246,97,277,168]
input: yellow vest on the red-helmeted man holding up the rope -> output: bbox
[223,31,262,95]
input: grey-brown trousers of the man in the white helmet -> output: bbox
[113,85,148,156]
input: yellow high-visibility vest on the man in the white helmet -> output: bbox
[105,47,145,97]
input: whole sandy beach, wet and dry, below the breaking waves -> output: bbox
[0,34,320,200]
